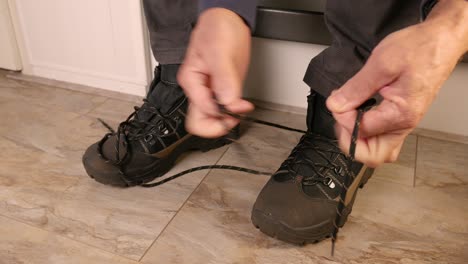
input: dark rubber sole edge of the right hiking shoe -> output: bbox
[251,168,374,245]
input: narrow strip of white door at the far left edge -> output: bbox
[0,0,22,71]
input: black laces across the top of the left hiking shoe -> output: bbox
[98,99,176,166]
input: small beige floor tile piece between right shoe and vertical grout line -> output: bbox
[372,135,418,186]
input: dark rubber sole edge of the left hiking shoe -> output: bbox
[83,129,239,188]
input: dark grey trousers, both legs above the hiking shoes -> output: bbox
[143,0,421,95]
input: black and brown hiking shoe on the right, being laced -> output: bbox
[251,95,373,245]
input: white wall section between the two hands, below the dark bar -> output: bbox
[244,38,326,108]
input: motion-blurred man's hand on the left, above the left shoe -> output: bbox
[178,8,253,137]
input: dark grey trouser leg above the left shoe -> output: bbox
[143,0,198,64]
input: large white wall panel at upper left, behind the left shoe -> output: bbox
[10,0,149,95]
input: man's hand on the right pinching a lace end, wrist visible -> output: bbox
[327,0,468,167]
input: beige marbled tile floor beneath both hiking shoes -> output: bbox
[0,71,468,264]
